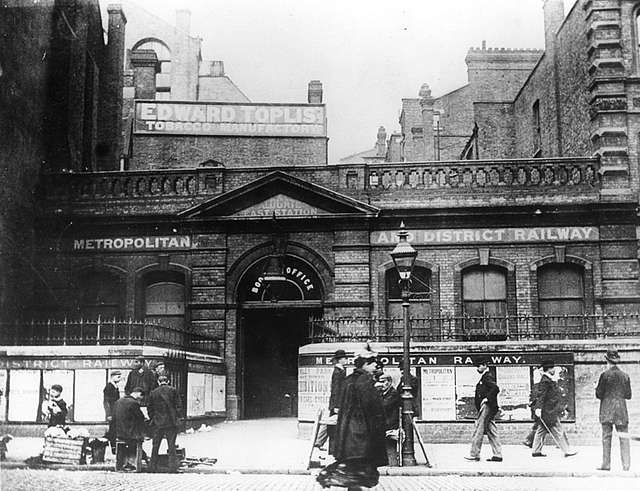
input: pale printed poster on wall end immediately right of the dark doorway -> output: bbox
[298,366,333,421]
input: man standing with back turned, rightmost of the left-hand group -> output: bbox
[147,375,180,472]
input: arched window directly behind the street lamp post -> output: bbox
[385,266,433,318]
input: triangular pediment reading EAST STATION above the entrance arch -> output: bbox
[179,171,379,219]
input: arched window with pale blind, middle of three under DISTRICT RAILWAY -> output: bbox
[462,266,507,317]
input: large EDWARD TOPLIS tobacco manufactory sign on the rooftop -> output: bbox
[135,101,327,138]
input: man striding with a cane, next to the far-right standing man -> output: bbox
[531,360,578,457]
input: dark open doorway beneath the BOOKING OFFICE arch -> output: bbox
[242,306,321,419]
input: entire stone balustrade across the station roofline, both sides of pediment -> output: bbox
[42,158,601,206]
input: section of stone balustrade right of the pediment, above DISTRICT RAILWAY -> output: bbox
[366,158,599,192]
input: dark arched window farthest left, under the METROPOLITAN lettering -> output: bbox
[78,271,125,319]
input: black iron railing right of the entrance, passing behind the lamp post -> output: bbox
[309,314,640,343]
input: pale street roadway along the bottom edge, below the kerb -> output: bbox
[0,469,640,491]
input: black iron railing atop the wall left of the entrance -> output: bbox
[0,317,219,355]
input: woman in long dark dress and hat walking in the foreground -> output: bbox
[318,349,387,490]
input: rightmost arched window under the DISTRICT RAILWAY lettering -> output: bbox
[538,264,584,316]
